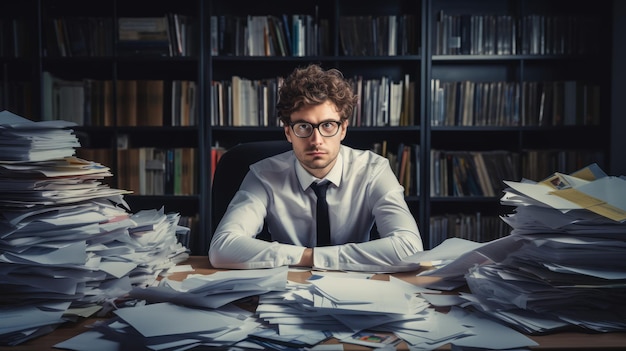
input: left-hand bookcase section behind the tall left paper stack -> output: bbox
[2,0,208,254]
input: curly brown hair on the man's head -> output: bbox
[276,64,357,125]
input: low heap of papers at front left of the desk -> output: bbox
[54,303,260,351]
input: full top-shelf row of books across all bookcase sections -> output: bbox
[0,12,597,57]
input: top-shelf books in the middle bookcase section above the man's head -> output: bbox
[210,14,419,56]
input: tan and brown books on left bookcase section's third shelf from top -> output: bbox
[117,147,197,195]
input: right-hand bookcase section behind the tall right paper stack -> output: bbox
[422,0,611,248]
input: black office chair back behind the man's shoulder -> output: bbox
[211,140,291,240]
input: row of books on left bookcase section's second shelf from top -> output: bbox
[43,72,198,126]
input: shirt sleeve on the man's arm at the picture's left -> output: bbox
[209,173,305,269]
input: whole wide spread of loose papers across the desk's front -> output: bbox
[55,267,536,350]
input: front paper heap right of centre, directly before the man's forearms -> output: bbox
[249,273,536,350]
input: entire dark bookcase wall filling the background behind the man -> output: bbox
[0,0,617,254]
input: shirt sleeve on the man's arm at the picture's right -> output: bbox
[313,158,423,272]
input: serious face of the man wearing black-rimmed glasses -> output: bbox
[284,101,348,178]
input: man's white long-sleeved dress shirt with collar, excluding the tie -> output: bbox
[209,145,423,272]
